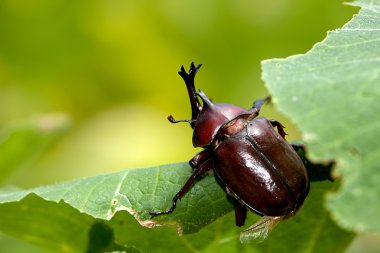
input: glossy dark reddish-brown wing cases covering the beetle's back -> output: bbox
[213,117,309,216]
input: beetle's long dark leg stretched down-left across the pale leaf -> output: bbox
[149,160,212,218]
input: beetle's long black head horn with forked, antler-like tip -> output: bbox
[178,62,202,128]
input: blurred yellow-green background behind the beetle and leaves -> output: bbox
[0,0,374,252]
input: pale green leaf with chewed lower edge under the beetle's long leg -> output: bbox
[0,163,231,233]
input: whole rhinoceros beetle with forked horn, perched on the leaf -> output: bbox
[150,63,309,240]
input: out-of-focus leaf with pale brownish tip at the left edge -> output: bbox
[0,114,70,183]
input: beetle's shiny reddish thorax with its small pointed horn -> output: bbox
[193,90,252,147]
